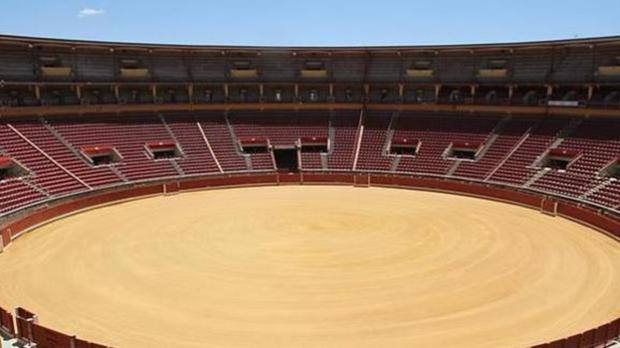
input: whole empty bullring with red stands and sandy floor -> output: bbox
[0,36,620,348]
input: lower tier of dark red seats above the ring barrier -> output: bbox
[0,110,620,213]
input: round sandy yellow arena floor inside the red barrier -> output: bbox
[0,186,620,347]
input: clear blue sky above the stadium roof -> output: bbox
[0,0,620,46]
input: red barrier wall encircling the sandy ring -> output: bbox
[0,172,620,348]
